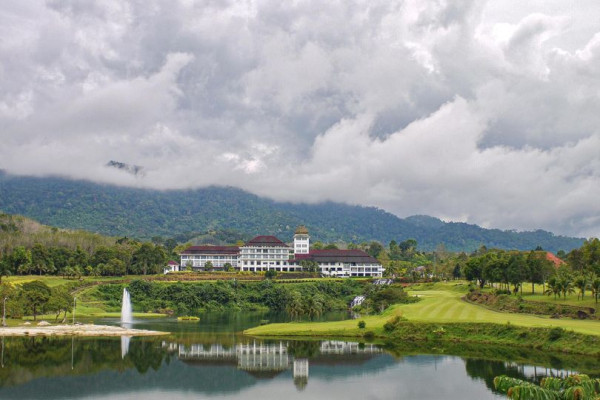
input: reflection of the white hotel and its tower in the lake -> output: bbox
[171,340,383,390]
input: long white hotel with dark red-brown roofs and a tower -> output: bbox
[180,226,384,277]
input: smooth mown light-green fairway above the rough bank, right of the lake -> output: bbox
[245,285,600,336]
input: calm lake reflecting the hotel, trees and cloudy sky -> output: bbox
[0,313,598,400]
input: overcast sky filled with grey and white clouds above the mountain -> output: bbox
[0,0,600,237]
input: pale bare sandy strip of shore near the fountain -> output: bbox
[0,324,169,336]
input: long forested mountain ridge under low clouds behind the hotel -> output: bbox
[0,172,583,252]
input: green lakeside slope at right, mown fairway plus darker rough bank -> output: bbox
[244,287,600,355]
